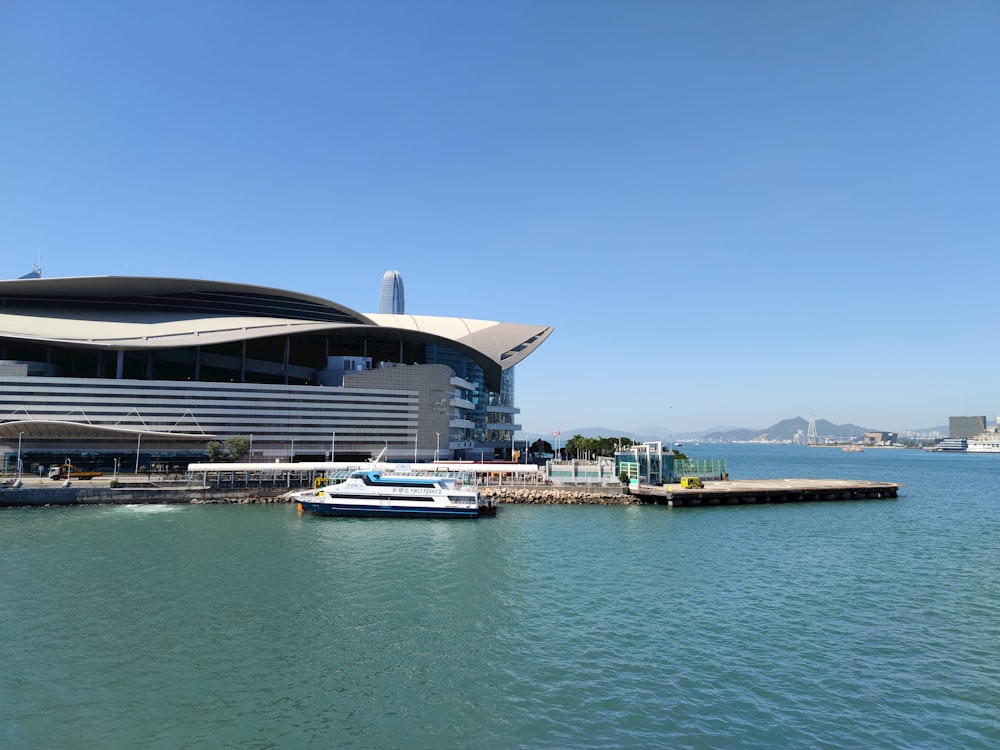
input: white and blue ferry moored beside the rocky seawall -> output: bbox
[292,469,497,518]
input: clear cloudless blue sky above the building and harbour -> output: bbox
[0,0,1000,435]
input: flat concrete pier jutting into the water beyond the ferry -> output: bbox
[631,479,902,508]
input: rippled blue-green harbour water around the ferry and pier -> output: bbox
[0,446,1000,748]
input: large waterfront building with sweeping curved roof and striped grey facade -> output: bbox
[0,276,552,471]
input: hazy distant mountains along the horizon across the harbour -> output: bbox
[522,417,948,444]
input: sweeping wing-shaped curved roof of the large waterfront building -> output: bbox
[0,276,552,380]
